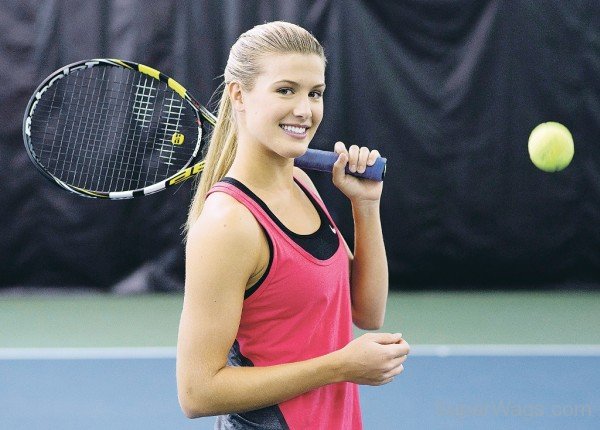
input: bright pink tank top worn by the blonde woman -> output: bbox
[209,179,362,430]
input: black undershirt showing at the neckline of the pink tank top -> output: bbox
[221,176,339,261]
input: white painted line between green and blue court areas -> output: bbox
[0,344,600,360]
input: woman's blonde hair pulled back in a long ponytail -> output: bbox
[185,21,325,231]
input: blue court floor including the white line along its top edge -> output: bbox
[0,345,600,430]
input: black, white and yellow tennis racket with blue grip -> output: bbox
[23,59,386,199]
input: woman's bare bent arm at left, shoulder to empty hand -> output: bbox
[177,194,408,418]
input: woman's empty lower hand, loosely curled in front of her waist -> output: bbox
[338,333,410,385]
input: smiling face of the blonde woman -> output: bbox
[237,54,325,158]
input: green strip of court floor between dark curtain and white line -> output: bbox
[0,291,600,348]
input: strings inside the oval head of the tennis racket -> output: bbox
[32,66,200,192]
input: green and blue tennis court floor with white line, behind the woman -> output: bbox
[0,292,600,430]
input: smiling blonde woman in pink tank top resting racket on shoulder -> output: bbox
[177,22,409,430]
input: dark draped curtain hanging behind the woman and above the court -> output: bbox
[0,0,600,292]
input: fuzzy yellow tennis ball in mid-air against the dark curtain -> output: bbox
[528,122,575,172]
